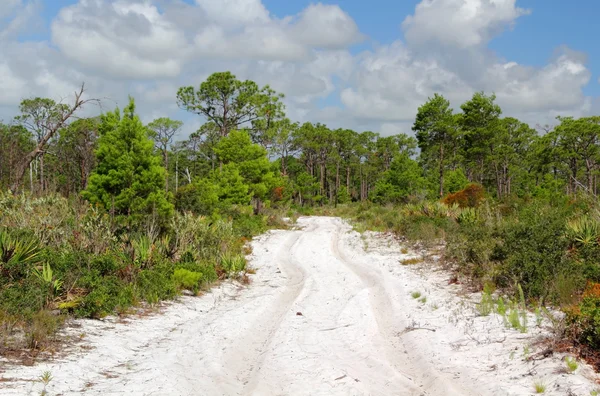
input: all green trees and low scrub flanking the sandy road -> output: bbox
[0,72,600,364]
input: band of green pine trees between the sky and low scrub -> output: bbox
[0,72,600,215]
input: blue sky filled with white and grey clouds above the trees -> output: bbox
[0,0,600,137]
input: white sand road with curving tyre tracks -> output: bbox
[0,217,597,395]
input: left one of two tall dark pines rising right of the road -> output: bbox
[412,94,458,197]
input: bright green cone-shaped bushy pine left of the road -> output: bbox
[82,98,173,224]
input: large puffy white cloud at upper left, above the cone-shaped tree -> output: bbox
[52,0,187,78]
